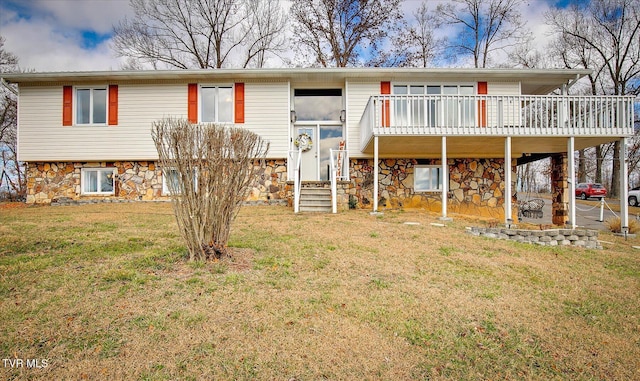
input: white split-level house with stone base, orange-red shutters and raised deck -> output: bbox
[3,68,633,224]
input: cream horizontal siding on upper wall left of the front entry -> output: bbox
[18,82,289,161]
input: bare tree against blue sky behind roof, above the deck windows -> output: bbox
[436,0,525,68]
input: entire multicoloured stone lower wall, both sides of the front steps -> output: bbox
[27,159,516,221]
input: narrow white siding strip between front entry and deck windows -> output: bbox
[346,81,380,158]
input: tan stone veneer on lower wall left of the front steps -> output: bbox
[27,159,287,204]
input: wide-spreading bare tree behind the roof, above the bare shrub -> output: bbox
[113,0,285,69]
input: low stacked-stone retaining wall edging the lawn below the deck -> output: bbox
[468,227,602,249]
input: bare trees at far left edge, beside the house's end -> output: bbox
[0,36,26,198]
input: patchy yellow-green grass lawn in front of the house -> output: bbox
[0,203,640,380]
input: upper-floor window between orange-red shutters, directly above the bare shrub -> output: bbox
[199,85,233,123]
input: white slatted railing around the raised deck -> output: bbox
[360,95,634,150]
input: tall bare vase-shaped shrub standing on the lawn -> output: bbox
[152,118,269,260]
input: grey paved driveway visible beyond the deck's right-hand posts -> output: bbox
[522,195,638,230]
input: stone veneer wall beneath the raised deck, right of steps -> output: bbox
[347,159,516,218]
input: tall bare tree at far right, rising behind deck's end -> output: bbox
[546,0,640,196]
